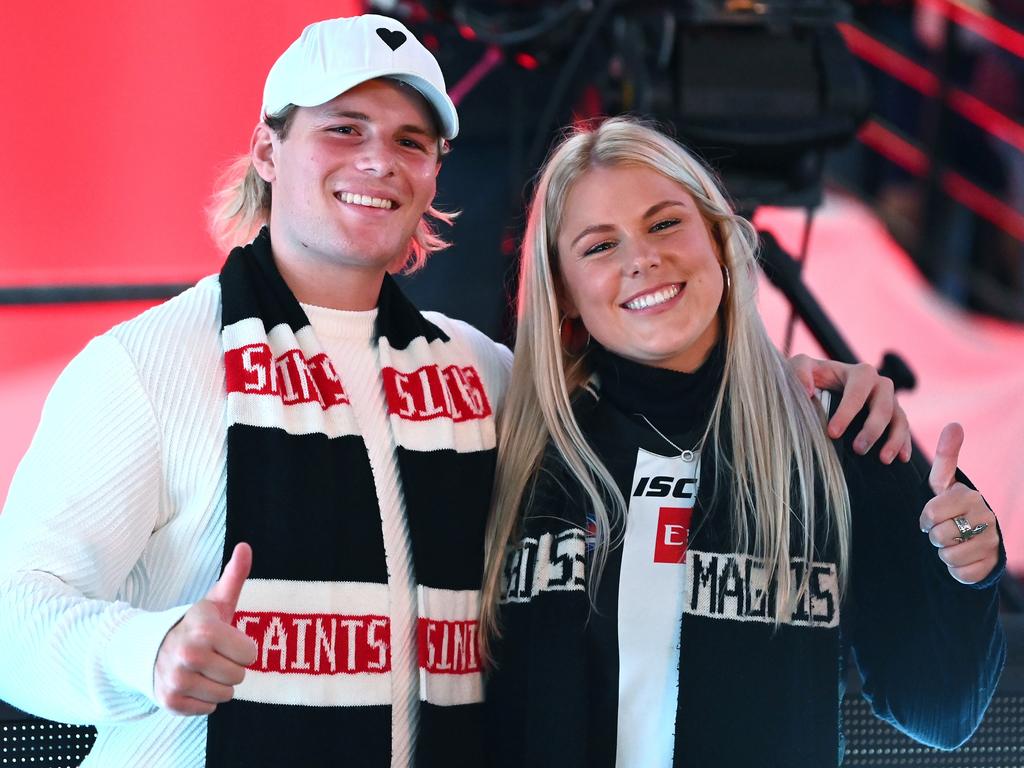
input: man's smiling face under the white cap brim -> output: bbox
[257,79,439,275]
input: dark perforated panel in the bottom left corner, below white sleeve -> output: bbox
[0,720,96,768]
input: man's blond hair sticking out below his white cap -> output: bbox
[207,95,459,274]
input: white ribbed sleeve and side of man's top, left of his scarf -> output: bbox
[0,279,226,768]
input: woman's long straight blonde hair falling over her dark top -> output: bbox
[481,118,850,658]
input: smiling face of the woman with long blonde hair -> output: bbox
[558,165,725,372]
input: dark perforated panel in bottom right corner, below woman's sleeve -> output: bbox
[843,694,1024,768]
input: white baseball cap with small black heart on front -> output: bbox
[260,13,459,139]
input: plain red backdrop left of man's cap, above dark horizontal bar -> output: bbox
[0,0,360,288]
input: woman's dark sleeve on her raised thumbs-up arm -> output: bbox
[837,411,1006,749]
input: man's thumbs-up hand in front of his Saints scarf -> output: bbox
[154,544,256,715]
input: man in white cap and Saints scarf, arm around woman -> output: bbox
[0,15,907,768]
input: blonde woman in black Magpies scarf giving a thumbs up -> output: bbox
[481,118,1005,768]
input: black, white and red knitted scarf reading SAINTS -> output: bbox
[207,229,495,768]
